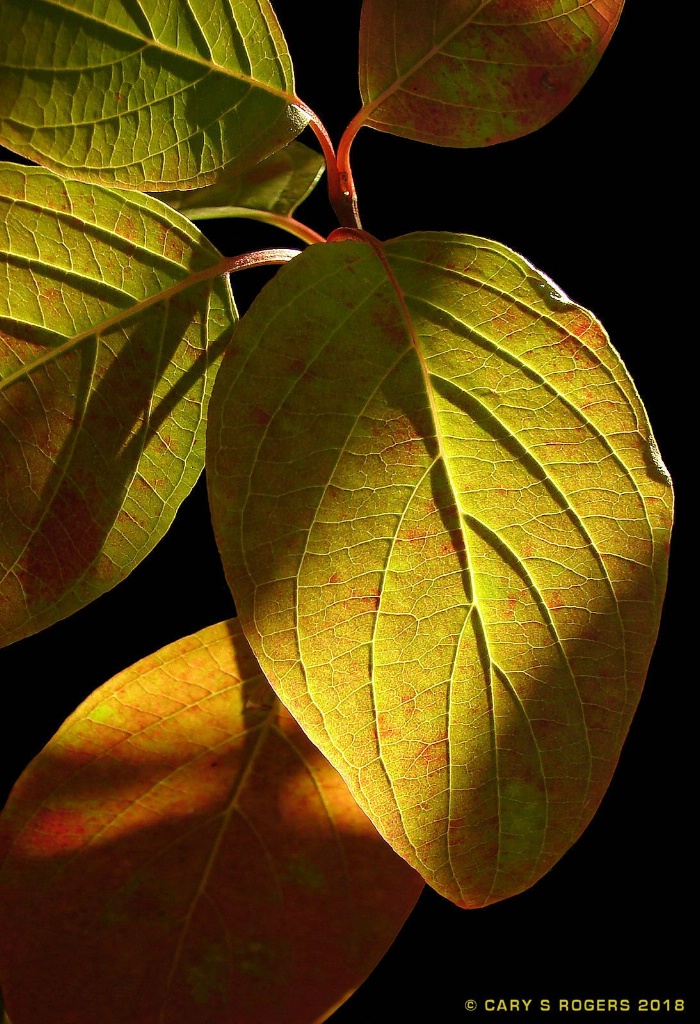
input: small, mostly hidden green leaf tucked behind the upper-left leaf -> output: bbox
[158,142,324,220]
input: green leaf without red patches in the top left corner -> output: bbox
[0,0,308,191]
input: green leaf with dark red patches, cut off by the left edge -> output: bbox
[0,164,235,643]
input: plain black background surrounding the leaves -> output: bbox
[0,0,697,1024]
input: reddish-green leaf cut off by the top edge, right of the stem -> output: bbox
[356,0,624,146]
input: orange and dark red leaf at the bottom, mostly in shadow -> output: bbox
[0,621,423,1024]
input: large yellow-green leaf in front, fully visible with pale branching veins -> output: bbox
[207,232,671,906]
